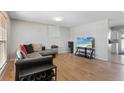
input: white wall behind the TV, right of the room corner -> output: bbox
[70,19,109,60]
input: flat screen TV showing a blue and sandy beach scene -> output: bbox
[76,37,94,48]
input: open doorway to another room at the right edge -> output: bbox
[111,28,124,64]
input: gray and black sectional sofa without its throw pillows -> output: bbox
[15,44,58,81]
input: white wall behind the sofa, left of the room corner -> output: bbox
[10,20,69,58]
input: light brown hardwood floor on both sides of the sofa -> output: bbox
[2,54,124,81]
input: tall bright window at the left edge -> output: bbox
[0,12,7,69]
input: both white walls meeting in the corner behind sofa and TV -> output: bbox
[10,20,109,60]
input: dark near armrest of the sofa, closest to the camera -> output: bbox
[15,56,53,80]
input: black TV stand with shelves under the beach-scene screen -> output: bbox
[75,47,95,58]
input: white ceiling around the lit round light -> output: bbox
[8,11,124,27]
